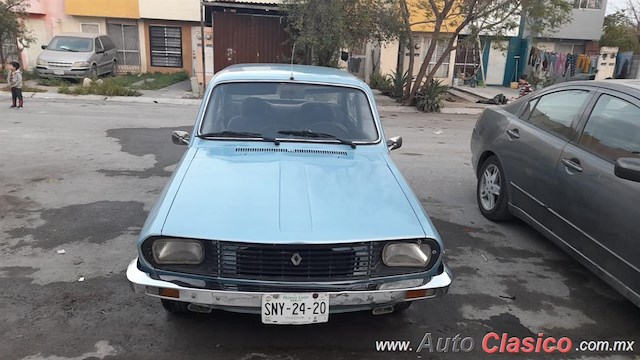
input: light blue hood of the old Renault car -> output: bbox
[162,149,425,243]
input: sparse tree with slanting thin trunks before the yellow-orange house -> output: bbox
[400,0,572,104]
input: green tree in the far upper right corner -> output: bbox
[600,11,640,53]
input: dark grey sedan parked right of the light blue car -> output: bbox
[471,80,640,306]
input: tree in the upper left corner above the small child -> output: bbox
[0,0,35,64]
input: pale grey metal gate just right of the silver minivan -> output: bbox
[107,19,140,73]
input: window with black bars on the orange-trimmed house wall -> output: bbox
[149,25,182,68]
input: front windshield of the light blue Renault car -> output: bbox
[200,82,378,143]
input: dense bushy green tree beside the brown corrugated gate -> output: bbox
[282,0,401,67]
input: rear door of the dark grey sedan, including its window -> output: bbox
[499,87,593,223]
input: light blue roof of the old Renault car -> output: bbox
[213,64,366,88]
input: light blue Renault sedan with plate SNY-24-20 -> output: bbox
[127,64,452,324]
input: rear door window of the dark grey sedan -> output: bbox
[529,90,589,139]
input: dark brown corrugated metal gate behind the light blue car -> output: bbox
[213,12,291,72]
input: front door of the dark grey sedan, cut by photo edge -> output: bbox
[551,90,640,295]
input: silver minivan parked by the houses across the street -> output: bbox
[36,33,118,78]
